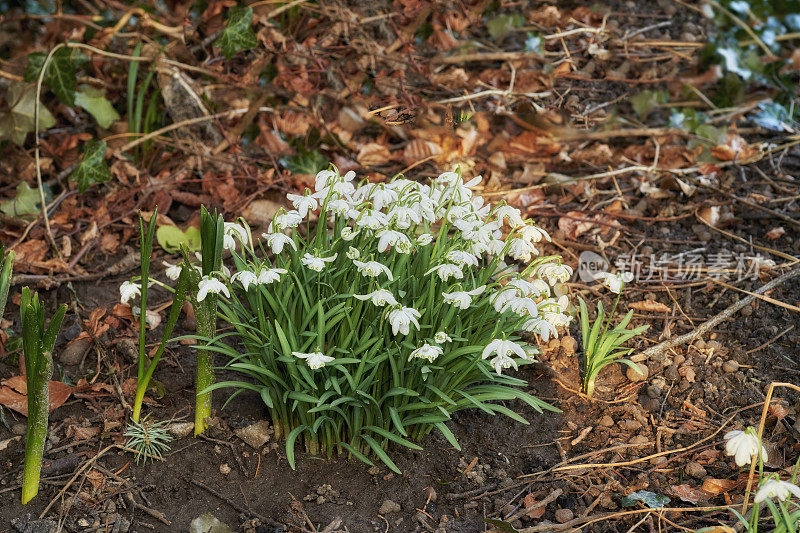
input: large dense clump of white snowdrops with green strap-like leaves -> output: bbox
[153,168,572,471]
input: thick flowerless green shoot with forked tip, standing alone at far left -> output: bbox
[20,287,67,504]
